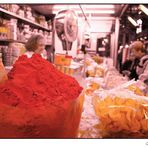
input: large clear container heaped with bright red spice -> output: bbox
[0,54,84,138]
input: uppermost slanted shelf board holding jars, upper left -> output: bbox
[0,8,51,32]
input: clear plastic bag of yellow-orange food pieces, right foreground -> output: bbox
[93,89,148,138]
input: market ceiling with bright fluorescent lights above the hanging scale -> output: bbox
[32,4,125,17]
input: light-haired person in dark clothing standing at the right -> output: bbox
[122,41,145,80]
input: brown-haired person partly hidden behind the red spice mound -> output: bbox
[25,34,47,59]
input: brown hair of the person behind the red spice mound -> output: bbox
[25,34,44,51]
